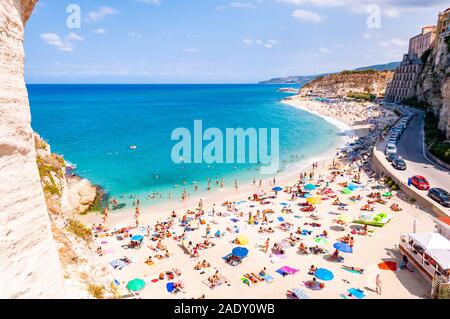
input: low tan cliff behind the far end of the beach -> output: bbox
[299,70,394,97]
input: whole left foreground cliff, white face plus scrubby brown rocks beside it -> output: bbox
[0,0,114,298]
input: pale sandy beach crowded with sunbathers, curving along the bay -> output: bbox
[81,97,433,299]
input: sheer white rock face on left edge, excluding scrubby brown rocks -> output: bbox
[0,0,66,298]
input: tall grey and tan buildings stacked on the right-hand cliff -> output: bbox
[384,26,436,103]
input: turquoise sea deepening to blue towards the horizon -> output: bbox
[27,84,339,205]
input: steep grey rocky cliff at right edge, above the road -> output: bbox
[416,35,450,139]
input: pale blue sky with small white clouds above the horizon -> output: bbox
[25,0,448,83]
